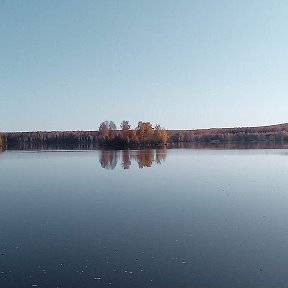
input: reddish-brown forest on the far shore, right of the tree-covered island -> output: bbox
[169,124,288,143]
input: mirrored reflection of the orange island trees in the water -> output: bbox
[99,148,167,169]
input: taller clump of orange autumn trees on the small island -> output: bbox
[99,120,168,146]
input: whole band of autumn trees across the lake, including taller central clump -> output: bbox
[0,120,288,149]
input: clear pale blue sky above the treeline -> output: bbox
[0,0,288,131]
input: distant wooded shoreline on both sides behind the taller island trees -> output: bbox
[1,123,288,148]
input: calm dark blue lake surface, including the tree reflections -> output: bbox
[0,149,288,288]
